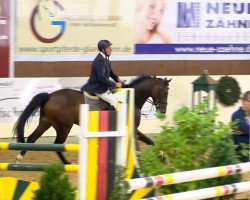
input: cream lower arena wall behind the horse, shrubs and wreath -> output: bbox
[0,75,250,138]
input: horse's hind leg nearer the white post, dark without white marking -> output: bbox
[54,124,73,164]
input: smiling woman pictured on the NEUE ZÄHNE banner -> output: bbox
[135,0,170,44]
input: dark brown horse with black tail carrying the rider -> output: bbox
[13,76,171,164]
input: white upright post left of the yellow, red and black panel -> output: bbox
[78,104,89,200]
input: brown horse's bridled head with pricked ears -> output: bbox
[151,78,172,113]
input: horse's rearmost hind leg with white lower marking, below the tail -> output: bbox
[16,120,51,163]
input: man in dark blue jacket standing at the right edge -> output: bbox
[232,91,250,162]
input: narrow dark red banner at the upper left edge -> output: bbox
[0,0,10,77]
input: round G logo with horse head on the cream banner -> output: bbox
[30,0,66,43]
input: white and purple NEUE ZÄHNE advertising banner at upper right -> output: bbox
[135,0,250,54]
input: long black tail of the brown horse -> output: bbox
[14,93,50,143]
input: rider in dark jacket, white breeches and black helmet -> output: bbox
[81,40,123,109]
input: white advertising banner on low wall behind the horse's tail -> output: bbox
[0,78,68,123]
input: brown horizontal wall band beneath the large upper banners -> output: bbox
[14,58,250,77]
